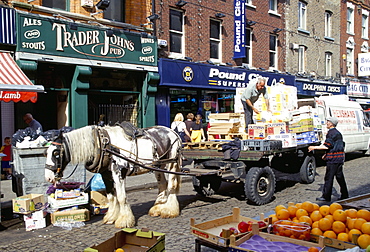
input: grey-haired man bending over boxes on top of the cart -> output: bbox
[241,77,270,132]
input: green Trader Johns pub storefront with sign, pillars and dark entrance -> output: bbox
[16,12,159,130]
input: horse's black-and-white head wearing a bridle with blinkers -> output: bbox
[45,133,69,183]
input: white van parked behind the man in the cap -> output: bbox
[298,95,370,153]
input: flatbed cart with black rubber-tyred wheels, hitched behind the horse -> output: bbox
[183,140,320,205]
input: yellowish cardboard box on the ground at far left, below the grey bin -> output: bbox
[12,194,45,214]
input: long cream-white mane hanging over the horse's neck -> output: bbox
[63,126,95,164]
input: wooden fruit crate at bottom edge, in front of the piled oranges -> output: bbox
[229,222,325,252]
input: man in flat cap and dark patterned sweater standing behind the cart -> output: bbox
[308,117,348,201]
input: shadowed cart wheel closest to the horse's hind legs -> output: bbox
[193,175,222,197]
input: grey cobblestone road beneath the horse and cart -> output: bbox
[0,155,370,252]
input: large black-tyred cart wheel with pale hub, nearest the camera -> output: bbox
[244,166,276,205]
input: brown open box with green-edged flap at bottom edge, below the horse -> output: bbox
[84,228,165,252]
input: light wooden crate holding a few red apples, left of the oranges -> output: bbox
[190,207,268,247]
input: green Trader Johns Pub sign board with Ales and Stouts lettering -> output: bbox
[17,13,157,66]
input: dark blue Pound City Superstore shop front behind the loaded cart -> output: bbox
[156,58,295,126]
